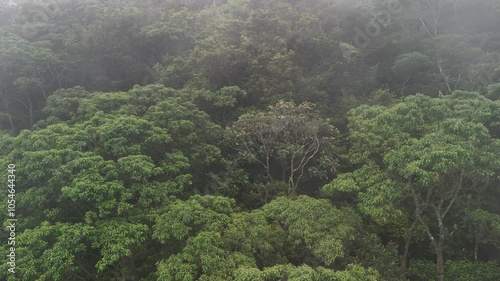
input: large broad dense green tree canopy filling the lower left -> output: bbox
[0,85,225,280]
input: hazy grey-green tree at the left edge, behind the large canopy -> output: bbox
[0,31,63,134]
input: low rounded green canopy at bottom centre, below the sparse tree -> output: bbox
[153,195,379,280]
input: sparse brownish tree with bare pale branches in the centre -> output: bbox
[226,101,335,197]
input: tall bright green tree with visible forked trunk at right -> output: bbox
[325,91,500,281]
